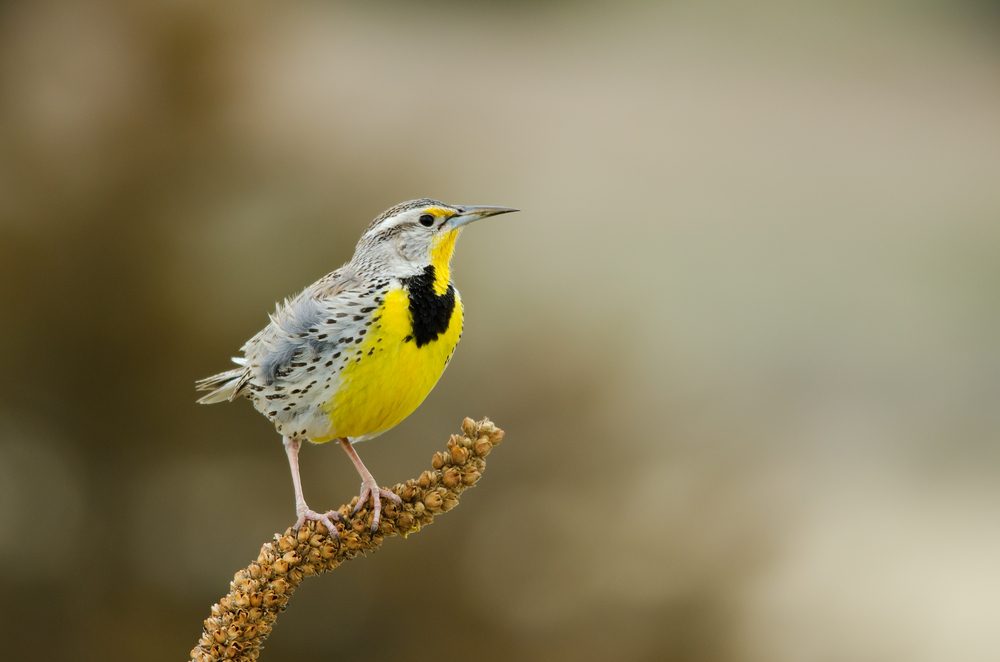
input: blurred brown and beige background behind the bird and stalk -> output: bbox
[0,0,1000,662]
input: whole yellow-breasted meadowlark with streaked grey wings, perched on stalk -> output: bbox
[197,198,517,534]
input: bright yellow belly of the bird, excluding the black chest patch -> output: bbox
[313,289,463,442]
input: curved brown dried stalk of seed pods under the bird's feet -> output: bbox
[191,418,503,662]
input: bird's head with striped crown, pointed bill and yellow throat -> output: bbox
[354,198,517,289]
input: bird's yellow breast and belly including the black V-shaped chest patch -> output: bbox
[315,269,463,441]
